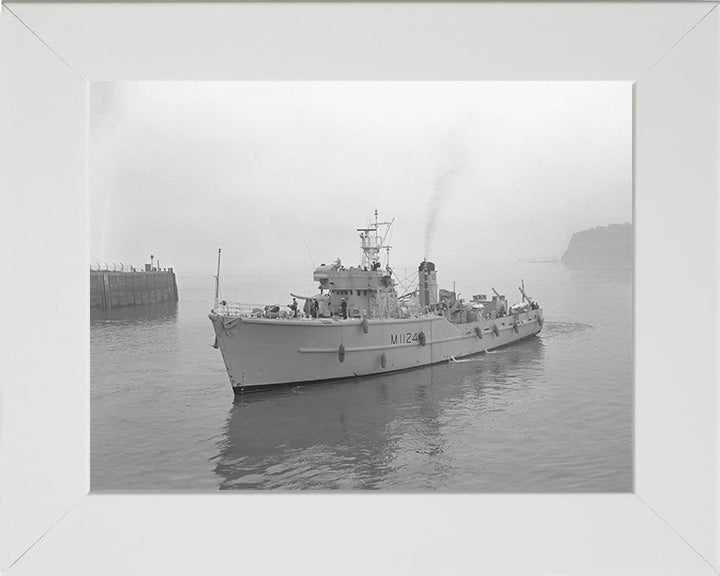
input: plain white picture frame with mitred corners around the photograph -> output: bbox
[0,2,720,576]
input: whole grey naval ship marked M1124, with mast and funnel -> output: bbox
[209,211,543,394]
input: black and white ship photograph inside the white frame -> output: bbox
[88,81,634,493]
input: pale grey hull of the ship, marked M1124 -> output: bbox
[210,309,542,393]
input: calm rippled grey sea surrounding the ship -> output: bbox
[91,262,633,492]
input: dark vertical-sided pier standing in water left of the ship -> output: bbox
[90,268,178,310]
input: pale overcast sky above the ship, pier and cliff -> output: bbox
[90,82,632,280]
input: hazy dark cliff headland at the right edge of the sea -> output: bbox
[562,224,633,266]
